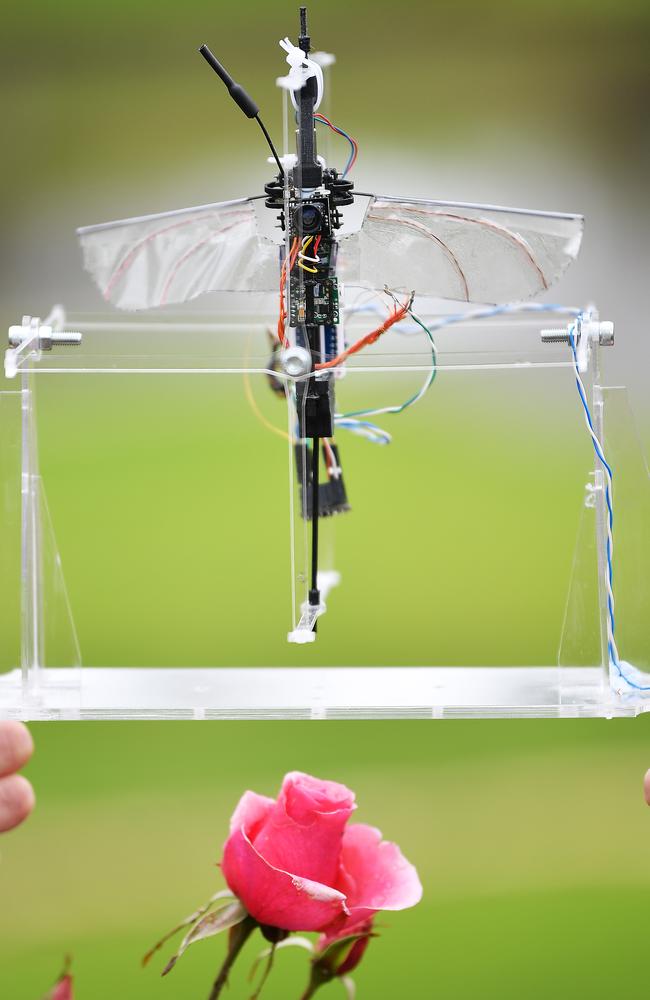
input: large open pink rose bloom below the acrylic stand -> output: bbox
[221,771,422,936]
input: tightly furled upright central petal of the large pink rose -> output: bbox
[249,771,355,885]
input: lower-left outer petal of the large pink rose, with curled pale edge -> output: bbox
[221,828,346,931]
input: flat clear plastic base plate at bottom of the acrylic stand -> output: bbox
[0,667,650,721]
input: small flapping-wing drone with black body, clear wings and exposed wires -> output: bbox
[78,7,583,642]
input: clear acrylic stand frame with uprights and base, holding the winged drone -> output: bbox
[0,300,650,719]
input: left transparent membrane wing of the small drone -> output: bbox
[77,198,280,309]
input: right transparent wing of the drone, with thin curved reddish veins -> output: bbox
[339,195,584,304]
